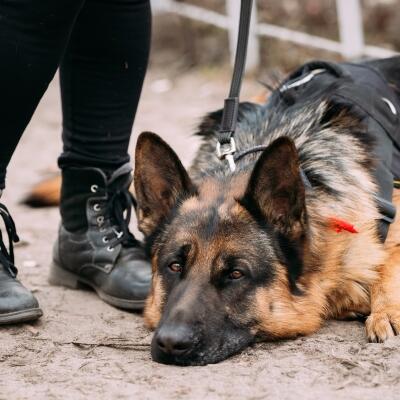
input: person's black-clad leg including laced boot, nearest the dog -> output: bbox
[50,0,151,309]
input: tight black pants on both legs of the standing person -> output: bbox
[0,0,151,189]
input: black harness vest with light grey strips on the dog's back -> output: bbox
[279,61,400,242]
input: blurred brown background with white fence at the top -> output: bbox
[152,0,400,75]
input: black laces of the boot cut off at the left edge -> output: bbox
[0,203,19,278]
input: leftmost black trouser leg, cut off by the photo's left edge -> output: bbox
[0,0,84,189]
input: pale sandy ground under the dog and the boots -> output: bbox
[0,66,400,400]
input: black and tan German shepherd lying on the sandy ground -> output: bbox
[134,57,400,365]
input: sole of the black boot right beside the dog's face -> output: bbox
[48,261,146,311]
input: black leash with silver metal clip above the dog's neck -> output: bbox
[217,0,253,171]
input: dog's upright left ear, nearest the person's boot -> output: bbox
[134,132,195,236]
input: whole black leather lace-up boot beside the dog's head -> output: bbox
[49,164,151,310]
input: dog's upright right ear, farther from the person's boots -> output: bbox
[241,137,306,239]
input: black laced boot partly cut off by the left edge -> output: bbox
[0,202,43,325]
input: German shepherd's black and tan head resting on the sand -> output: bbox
[135,133,315,365]
